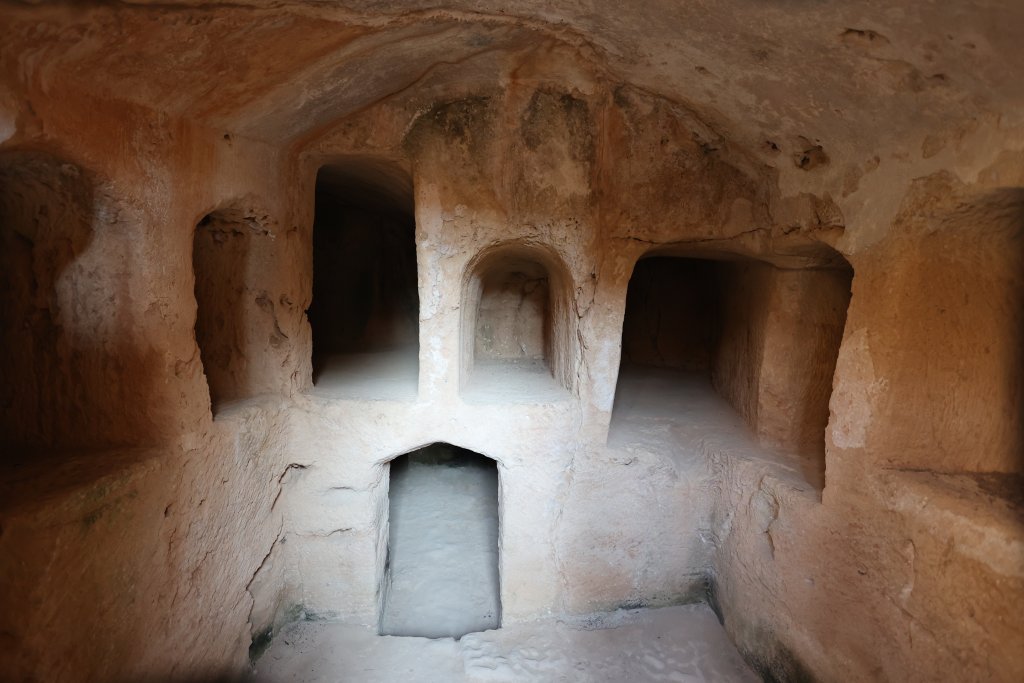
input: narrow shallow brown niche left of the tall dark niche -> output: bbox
[193,210,269,416]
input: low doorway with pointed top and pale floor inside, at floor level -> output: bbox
[380,443,501,638]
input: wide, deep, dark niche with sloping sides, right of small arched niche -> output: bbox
[609,254,852,485]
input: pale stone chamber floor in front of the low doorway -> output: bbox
[255,604,760,683]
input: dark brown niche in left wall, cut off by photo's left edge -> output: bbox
[0,152,96,450]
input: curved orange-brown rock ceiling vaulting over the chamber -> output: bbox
[0,0,1024,244]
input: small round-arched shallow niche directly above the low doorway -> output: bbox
[462,243,571,402]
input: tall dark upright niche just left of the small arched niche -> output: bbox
[307,159,419,399]
